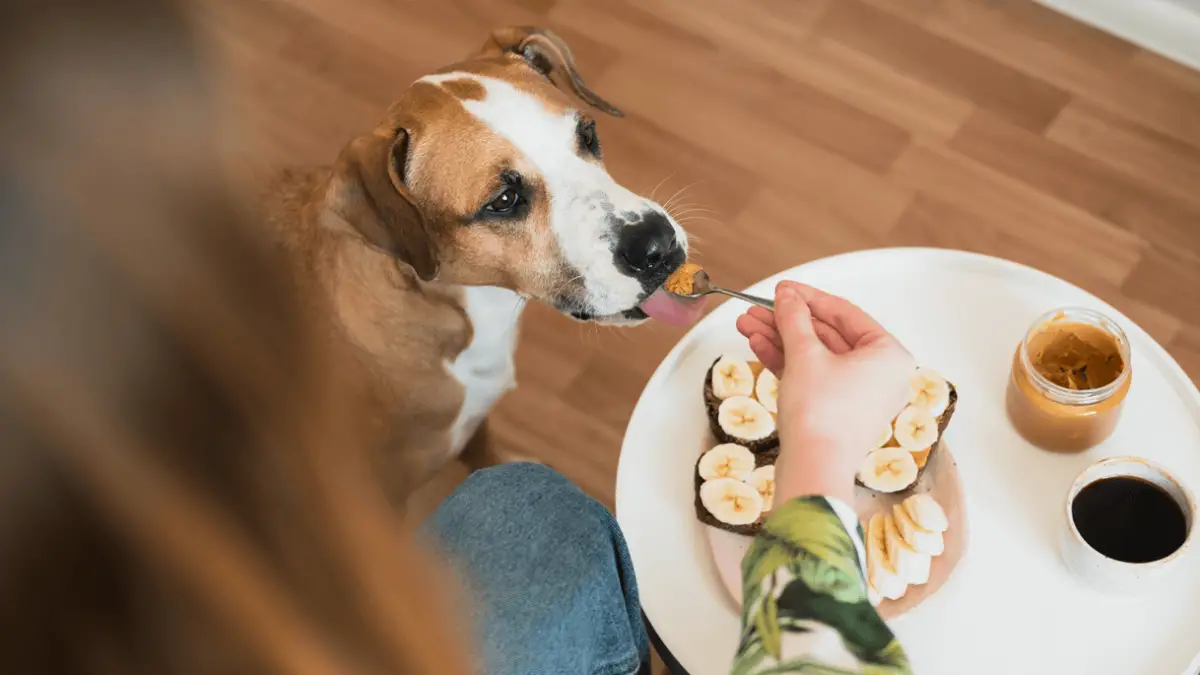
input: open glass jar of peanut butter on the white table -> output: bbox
[1006,307,1133,453]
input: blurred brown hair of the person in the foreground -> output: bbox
[0,0,464,675]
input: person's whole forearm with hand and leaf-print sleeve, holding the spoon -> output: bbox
[733,281,916,675]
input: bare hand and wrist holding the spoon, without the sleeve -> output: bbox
[737,281,917,504]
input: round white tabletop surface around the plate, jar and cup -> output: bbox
[617,249,1200,675]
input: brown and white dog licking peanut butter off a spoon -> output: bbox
[266,28,688,496]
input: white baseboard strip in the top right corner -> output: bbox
[1037,0,1200,70]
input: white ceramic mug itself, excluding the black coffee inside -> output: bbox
[1058,456,1196,593]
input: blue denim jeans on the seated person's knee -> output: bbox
[425,464,650,675]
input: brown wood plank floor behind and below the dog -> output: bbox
[200,0,1200,504]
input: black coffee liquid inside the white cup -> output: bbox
[1070,476,1188,562]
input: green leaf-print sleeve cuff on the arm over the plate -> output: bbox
[733,497,911,675]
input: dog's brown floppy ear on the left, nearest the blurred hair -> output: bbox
[334,129,438,281]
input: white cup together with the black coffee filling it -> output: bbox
[1060,456,1196,593]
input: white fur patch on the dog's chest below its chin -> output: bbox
[450,286,526,455]
